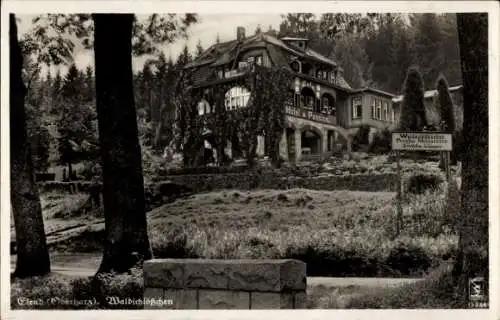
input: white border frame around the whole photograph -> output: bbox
[0,0,500,320]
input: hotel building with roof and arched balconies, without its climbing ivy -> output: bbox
[185,27,460,161]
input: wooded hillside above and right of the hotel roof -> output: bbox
[279,13,461,94]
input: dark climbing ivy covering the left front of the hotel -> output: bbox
[175,66,290,166]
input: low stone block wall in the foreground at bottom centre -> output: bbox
[144,259,306,309]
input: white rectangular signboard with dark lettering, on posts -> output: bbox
[392,132,453,151]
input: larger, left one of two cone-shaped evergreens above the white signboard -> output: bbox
[399,67,427,131]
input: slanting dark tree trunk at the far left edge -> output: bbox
[9,14,50,278]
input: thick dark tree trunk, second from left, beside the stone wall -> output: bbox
[93,14,152,273]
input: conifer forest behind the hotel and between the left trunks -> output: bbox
[21,13,461,171]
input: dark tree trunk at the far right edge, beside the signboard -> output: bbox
[455,13,489,306]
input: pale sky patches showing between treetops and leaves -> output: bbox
[18,13,281,74]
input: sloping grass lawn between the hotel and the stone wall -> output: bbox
[48,184,458,277]
